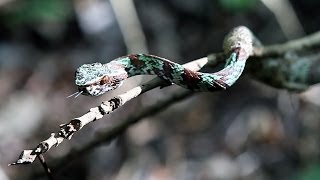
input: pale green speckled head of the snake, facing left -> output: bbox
[75,62,127,96]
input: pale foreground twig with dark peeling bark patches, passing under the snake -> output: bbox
[10,53,225,165]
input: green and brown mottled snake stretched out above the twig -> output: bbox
[75,26,252,96]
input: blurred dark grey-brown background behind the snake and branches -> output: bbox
[0,0,320,180]
